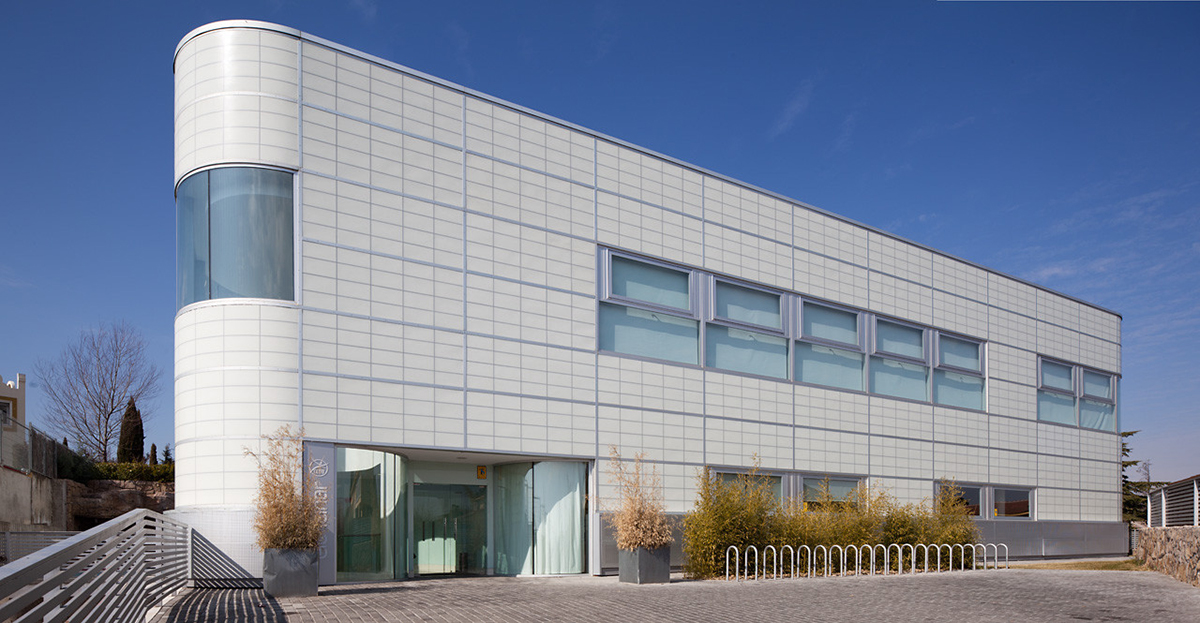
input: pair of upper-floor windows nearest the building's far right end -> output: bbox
[1038,358,1116,431]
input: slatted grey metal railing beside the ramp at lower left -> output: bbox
[0,509,191,623]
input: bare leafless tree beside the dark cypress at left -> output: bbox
[35,321,162,461]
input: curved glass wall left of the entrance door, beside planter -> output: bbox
[337,448,408,582]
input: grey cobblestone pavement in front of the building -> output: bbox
[152,569,1200,623]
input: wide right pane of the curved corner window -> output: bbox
[209,168,294,300]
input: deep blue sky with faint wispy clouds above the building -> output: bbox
[0,0,1200,480]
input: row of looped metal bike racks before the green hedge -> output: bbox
[725,543,1008,580]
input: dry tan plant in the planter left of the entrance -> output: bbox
[244,426,325,550]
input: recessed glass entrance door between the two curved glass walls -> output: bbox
[413,483,487,575]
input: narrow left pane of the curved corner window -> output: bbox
[175,172,209,308]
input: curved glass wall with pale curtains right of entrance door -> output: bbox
[494,461,588,575]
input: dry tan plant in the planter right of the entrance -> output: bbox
[608,445,674,551]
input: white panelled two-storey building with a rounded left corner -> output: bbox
[174,22,1127,582]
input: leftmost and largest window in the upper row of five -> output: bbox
[599,254,700,365]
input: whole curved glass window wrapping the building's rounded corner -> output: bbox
[175,167,295,307]
